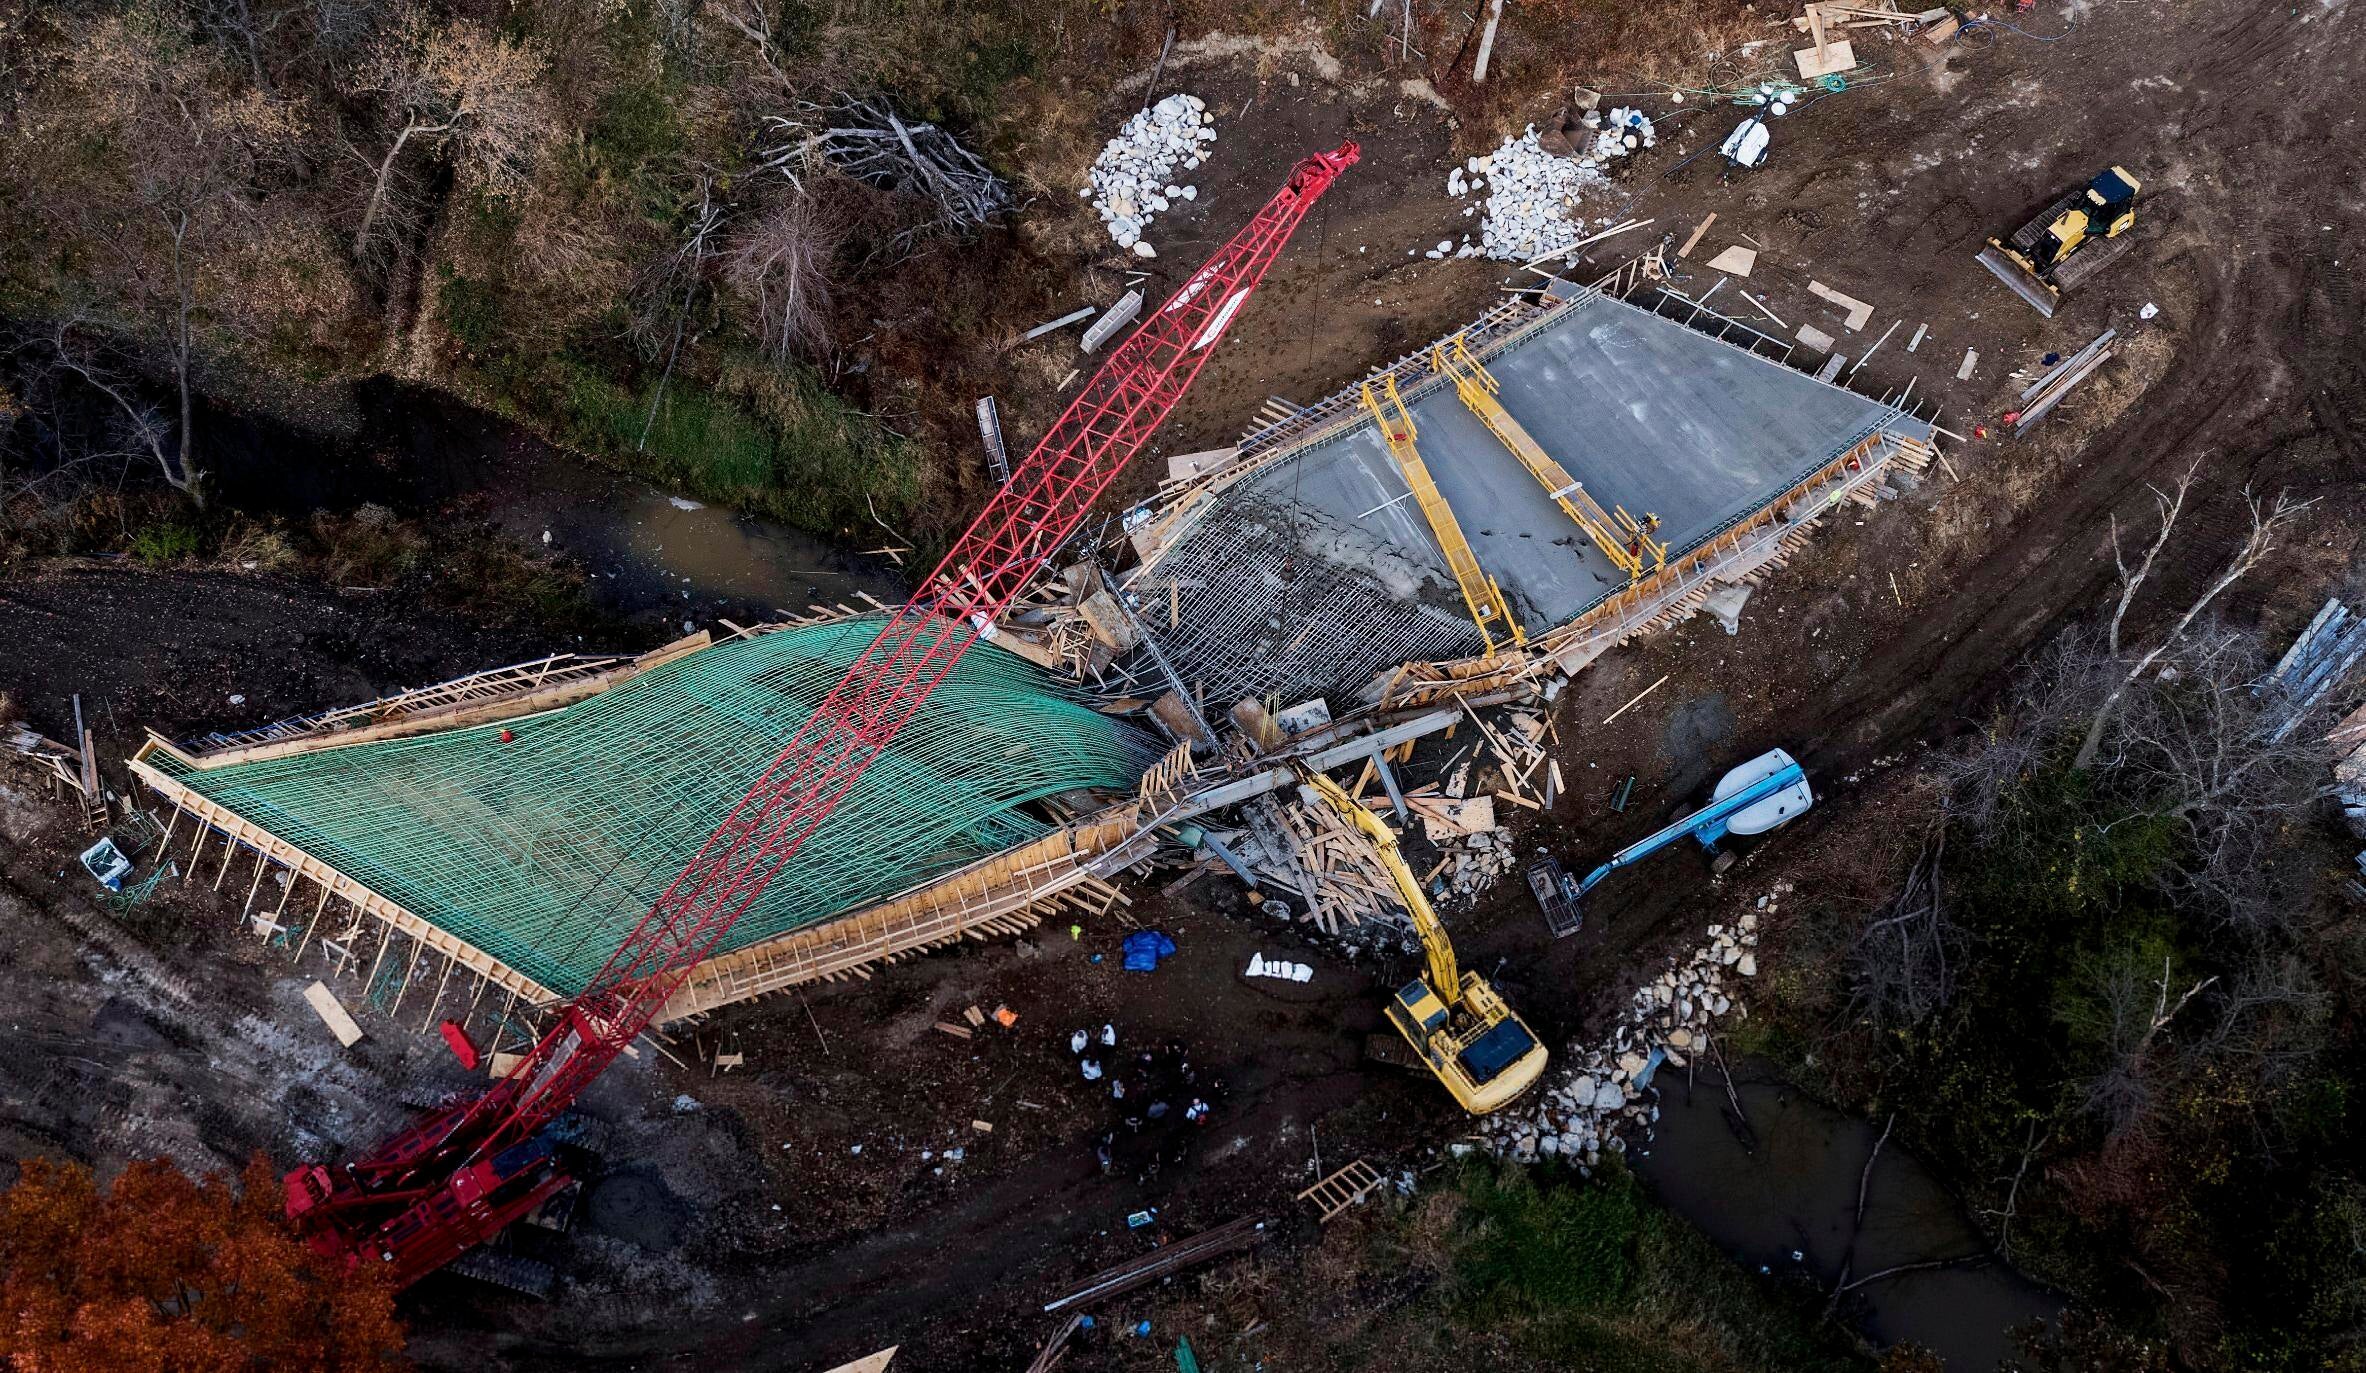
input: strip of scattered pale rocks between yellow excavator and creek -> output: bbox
[1479,881,1791,1174]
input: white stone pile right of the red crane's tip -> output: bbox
[1424,107,1659,263]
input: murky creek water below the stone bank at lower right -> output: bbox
[1628,1061,2061,1373]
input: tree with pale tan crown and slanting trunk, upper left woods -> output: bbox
[353,12,551,256]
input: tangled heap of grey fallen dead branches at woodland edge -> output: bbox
[762,95,1017,246]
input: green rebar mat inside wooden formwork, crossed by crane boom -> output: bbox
[156,615,1157,994]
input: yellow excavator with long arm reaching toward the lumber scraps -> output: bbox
[1301,769,1545,1115]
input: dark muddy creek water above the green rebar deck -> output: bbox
[213,381,901,632]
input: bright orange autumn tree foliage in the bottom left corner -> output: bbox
[0,1153,402,1373]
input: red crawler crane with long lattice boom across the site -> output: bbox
[286,142,1358,1288]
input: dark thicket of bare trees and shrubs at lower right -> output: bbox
[1753,637,2366,1373]
